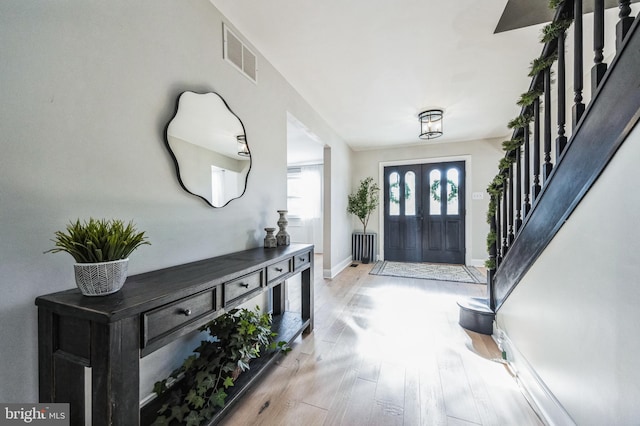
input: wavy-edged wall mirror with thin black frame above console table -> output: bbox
[165,91,251,207]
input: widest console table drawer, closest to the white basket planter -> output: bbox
[143,289,216,346]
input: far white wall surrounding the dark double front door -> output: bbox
[351,137,507,265]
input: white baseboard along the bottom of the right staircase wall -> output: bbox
[492,322,576,426]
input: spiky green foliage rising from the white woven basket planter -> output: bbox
[45,218,151,263]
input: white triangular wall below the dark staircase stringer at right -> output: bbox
[497,122,640,425]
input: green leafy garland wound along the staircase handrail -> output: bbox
[485,0,573,269]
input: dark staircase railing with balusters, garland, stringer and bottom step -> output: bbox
[459,0,640,334]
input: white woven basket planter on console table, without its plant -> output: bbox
[73,258,129,296]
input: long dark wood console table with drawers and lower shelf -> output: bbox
[36,244,314,426]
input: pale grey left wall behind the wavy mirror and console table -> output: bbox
[0,0,351,402]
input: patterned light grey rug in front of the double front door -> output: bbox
[369,260,487,284]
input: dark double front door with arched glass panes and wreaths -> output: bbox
[384,161,465,264]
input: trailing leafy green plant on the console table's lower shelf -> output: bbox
[153,306,290,426]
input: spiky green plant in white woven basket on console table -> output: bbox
[45,218,150,296]
